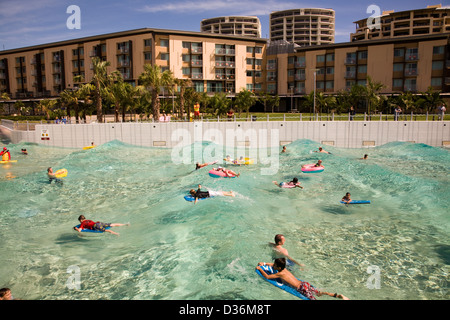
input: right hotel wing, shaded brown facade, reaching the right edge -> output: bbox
[266,33,450,109]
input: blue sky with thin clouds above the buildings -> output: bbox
[0,0,444,50]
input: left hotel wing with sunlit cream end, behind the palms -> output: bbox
[0,28,266,99]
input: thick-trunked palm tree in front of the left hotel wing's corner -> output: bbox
[139,64,175,121]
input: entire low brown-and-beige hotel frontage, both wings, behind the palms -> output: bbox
[0,29,450,111]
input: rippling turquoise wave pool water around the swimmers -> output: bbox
[0,140,450,300]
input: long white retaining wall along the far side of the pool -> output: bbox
[0,121,450,148]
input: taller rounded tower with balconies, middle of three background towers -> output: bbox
[270,8,335,46]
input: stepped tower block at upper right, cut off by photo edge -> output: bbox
[350,5,450,41]
